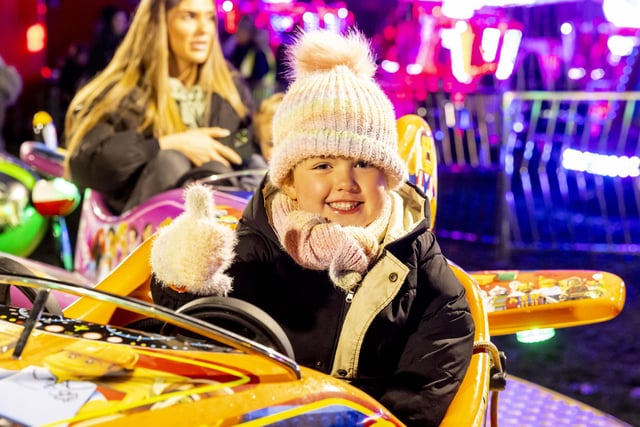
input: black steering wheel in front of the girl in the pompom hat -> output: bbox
[161,297,295,360]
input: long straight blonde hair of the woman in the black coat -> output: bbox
[65,0,249,173]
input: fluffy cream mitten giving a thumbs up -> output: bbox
[151,184,236,296]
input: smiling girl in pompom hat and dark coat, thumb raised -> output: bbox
[152,30,474,426]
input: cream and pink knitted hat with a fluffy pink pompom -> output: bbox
[269,30,407,188]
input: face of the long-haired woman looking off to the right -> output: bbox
[167,0,216,76]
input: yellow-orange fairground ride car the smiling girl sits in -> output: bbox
[0,116,625,427]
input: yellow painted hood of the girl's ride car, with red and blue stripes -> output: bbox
[0,312,396,426]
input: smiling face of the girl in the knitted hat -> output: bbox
[283,157,387,227]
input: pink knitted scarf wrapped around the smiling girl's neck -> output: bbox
[271,192,391,291]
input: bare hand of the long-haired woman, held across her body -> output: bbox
[158,127,242,167]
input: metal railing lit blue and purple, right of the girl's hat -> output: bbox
[410,91,640,254]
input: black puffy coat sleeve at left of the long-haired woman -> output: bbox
[69,110,160,193]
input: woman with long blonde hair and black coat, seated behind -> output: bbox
[65,0,258,213]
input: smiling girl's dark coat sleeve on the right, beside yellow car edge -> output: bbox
[380,238,475,426]
